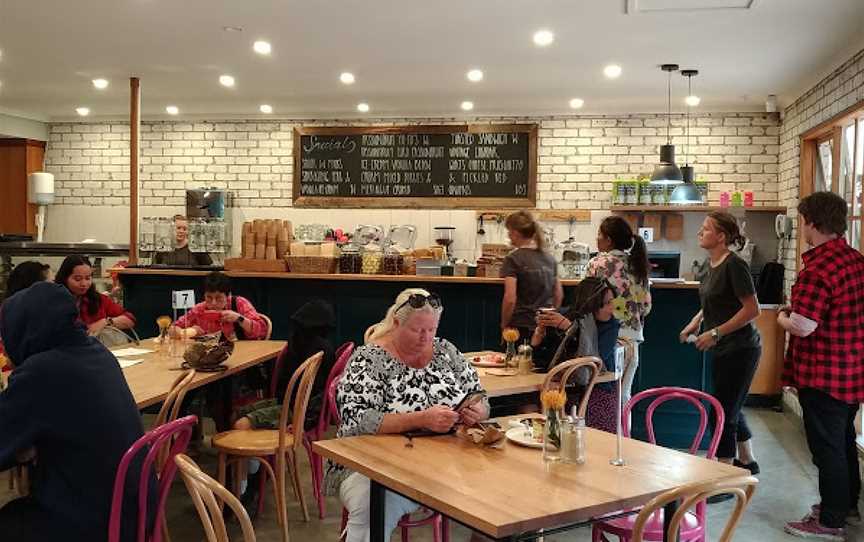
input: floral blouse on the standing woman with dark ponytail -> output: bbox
[587,250,651,341]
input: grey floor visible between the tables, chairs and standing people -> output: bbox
[0,410,864,542]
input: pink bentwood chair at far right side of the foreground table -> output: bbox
[591,387,725,542]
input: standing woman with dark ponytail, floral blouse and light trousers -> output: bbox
[587,215,651,403]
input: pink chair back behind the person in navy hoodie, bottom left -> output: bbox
[108,416,198,542]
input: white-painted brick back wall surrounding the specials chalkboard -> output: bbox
[45,113,780,210]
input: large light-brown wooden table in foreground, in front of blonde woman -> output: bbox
[312,429,747,542]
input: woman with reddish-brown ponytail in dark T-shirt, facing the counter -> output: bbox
[501,211,564,339]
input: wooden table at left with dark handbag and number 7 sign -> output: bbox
[118,340,286,409]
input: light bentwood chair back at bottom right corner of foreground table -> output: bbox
[631,476,759,542]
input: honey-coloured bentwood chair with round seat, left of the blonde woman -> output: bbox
[213,352,324,542]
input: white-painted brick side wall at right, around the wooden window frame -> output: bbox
[778,46,864,294]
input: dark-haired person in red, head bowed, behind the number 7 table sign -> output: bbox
[172,271,267,340]
